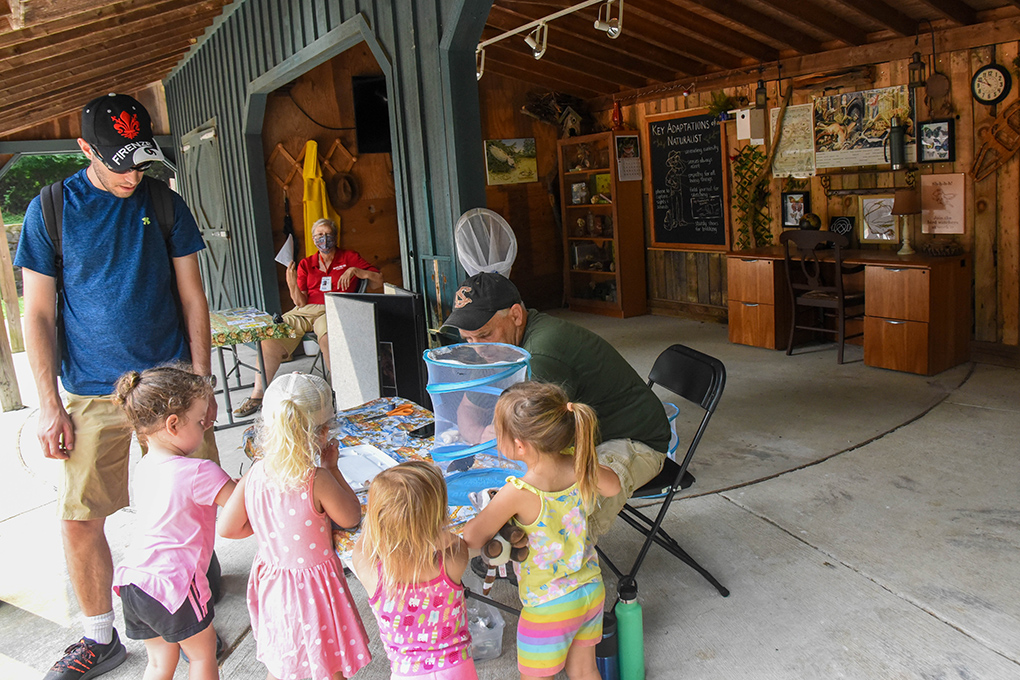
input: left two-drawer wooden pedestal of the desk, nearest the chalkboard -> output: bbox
[726,255,789,350]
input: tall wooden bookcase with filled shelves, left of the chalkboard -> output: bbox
[559,130,647,317]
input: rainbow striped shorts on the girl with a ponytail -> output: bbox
[517,579,606,676]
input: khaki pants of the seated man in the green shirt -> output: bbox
[588,439,666,541]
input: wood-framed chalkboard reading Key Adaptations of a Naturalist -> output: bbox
[645,113,729,250]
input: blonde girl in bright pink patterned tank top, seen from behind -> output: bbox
[353,462,477,680]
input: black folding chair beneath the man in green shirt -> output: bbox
[596,345,729,597]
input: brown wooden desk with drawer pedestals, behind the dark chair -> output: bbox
[726,246,973,375]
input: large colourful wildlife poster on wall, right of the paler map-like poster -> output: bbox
[814,85,917,168]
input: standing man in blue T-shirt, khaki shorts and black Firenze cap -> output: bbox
[15,94,218,680]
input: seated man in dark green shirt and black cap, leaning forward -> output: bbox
[444,272,670,539]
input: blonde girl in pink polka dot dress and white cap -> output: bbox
[217,373,371,680]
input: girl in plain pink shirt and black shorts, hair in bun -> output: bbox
[113,366,235,680]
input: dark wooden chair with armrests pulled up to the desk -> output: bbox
[779,229,864,364]
